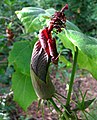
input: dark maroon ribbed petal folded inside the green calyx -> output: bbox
[31,41,51,82]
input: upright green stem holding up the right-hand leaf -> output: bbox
[66,47,78,107]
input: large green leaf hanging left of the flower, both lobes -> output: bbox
[8,40,36,110]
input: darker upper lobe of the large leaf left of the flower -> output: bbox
[8,40,36,75]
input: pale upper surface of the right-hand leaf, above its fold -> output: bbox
[66,30,97,60]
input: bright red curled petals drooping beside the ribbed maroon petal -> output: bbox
[39,27,58,63]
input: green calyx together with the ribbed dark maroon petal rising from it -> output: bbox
[31,41,55,99]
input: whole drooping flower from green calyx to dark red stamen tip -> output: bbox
[30,5,68,99]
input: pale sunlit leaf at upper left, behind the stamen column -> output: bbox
[15,7,55,33]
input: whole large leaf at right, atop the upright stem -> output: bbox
[58,30,97,79]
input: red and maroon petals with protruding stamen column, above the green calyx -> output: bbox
[31,5,68,82]
